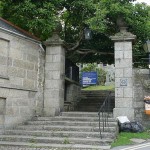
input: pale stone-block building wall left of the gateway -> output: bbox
[0,29,45,131]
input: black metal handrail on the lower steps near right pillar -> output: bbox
[98,91,111,139]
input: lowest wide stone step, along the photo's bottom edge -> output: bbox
[0,141,110,150]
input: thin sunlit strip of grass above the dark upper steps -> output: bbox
[82,85,115,91]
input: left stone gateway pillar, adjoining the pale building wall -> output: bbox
[44,33,65,116]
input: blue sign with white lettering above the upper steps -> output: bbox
[82,72,97,85]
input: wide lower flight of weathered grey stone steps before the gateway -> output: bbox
[0,112,118,150]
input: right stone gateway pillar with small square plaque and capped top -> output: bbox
[110,18,136,120]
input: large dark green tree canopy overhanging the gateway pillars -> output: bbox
[0,0,150,63]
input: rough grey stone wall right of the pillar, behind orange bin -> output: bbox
[133,69,150,126]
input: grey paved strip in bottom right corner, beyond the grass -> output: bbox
[112,142,150,150]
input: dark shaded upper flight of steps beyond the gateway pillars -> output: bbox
[77,90,115,112]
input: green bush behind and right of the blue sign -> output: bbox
[81,63,106,85]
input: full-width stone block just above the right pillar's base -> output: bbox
[115,98,133,108]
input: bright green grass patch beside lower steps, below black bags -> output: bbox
[111,131,150,147]
